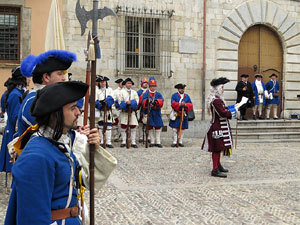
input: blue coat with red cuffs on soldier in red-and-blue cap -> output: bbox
[142,91,164,127]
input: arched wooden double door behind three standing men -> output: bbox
[238,25,283,117]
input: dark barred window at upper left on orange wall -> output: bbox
[0,6,20,63]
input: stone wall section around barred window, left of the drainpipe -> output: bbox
[63,0,203,118]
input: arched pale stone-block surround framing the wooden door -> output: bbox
[216,0,300,118]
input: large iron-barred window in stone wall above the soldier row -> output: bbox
[117,6,173,75]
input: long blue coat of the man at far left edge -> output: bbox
[0,88,23,172]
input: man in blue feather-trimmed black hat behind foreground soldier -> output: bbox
[17,50,76,136]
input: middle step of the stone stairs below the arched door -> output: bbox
[231,126,300,133]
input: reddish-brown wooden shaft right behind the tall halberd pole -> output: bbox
[83,32,91,125]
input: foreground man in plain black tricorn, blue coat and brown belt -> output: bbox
[5,81,100,225]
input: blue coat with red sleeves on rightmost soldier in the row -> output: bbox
[169,92,193,129]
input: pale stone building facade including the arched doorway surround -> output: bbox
[0,0,300,129]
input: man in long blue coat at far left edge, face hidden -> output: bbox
[0,67,26,172]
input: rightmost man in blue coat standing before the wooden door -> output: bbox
[266,73,280,120]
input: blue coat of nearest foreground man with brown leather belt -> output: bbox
[5,132,81,225]
